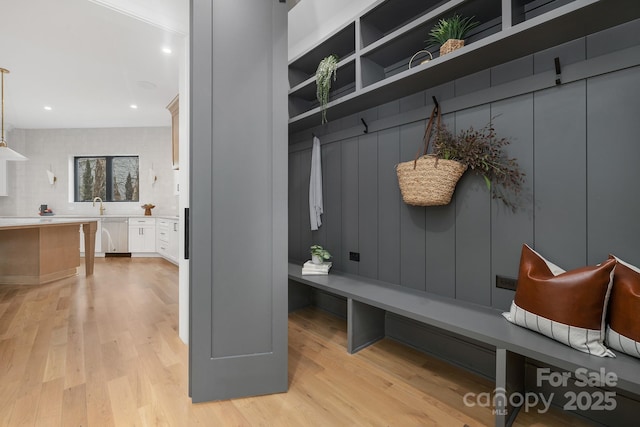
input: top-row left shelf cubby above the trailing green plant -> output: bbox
[289,22,356,88]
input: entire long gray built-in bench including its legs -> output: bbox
[289,263,640,426]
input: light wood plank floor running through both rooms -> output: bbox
[0,258,585,427]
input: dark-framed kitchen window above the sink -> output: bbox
[74,156,140,202]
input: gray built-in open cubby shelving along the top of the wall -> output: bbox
[289,0,640,132]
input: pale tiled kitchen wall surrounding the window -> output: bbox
[0,127,178,216]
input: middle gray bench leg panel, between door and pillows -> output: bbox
[347,298,385,354]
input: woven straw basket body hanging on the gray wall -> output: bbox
[396,155,467,206]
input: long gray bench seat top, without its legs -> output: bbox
[289,262,640,395]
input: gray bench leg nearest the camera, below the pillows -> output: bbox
[495,348,525,427]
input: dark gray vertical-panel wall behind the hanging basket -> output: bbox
[289,21,640,309]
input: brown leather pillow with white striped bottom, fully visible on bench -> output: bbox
[503,245,616,357]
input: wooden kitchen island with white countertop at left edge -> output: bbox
[0,218,98,285]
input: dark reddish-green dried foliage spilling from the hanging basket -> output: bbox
[433,123,524,211]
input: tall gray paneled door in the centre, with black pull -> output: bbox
[189,0,288,402]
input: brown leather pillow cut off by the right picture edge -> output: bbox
[607,255,640,358]
